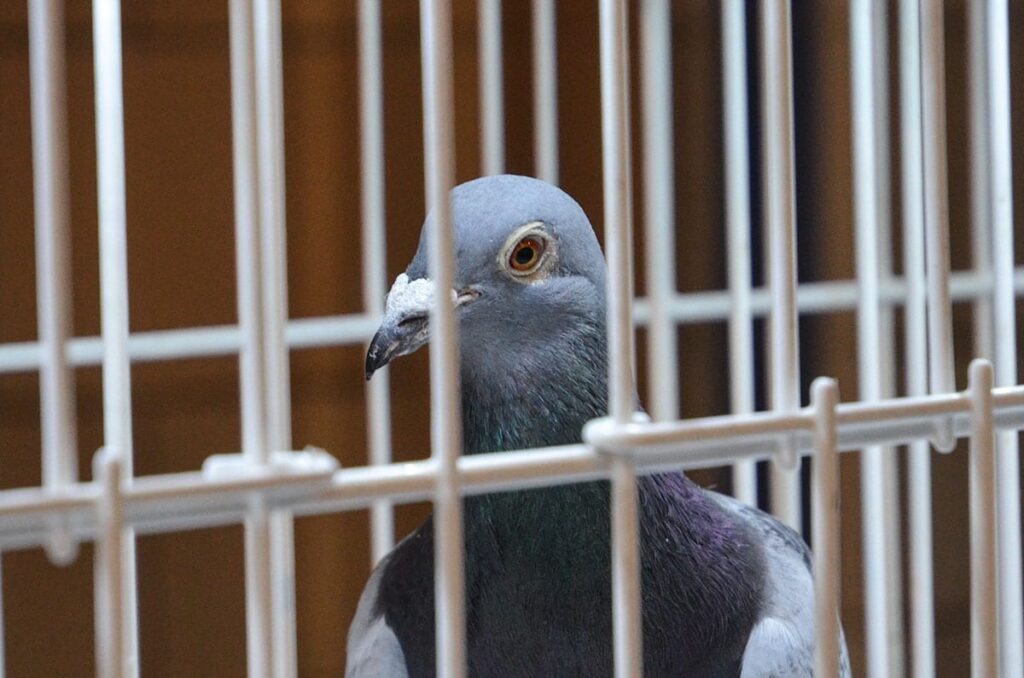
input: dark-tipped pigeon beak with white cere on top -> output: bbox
[367,273,480,381]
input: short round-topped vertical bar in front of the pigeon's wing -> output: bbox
[811,377,842,676]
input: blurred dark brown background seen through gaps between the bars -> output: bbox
[0,0,1024,677]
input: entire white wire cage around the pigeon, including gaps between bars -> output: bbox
[0,0,1024,677]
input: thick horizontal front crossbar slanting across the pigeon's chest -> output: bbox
[8,386,1024,549]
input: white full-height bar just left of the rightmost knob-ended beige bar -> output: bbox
[899,0,935,678]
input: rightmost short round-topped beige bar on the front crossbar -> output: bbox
[968,358,1000,676]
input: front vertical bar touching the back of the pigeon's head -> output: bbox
[600,0,643,678]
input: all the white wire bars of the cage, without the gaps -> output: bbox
[0,0,1024,677]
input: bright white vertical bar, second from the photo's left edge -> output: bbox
[92,0,138,676]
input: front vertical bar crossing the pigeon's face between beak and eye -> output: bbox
[420,0,466,678]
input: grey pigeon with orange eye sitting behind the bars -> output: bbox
[345,175,850,678]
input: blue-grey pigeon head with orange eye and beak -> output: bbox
[367,175,605,380]
